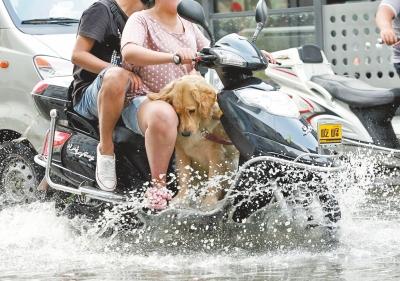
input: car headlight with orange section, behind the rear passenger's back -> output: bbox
[33,56,74,79]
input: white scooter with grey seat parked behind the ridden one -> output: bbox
[266,45,400,167]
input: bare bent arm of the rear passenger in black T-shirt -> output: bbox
[71,35,111,74]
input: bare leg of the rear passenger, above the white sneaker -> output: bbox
[97,67,129,155]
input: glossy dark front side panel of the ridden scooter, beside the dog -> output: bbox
[218,85,318,161]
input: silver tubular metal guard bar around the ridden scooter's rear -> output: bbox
[39,109,127,204]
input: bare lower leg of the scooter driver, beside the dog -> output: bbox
[138,100,178,185]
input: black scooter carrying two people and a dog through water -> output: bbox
[28,0,341,232]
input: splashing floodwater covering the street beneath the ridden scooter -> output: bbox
[0,154,400,280]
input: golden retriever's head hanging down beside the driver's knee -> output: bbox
[148,75,221,137]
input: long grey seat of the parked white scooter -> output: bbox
[311,74,400,108]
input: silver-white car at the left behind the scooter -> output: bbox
[0,0,94,202]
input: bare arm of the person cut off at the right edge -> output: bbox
[375,5,398,45]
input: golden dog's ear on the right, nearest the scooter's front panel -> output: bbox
[193,81,217,119]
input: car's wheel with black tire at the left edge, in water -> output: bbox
[0,142,45,203]
